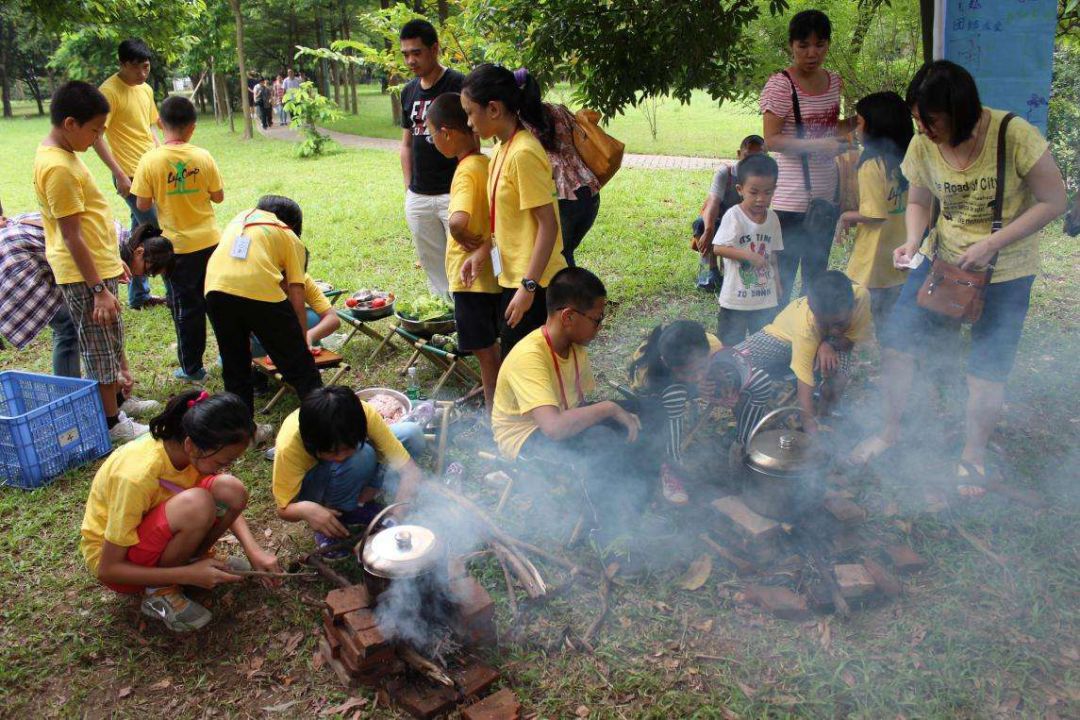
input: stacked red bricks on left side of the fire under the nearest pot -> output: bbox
[320,585,403,688]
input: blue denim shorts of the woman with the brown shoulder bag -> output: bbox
[878,258,1035,382]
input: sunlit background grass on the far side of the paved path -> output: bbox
[319,84,761,158]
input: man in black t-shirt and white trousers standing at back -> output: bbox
[400,19,464,296]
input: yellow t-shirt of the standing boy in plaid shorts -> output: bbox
[33,145,123,285]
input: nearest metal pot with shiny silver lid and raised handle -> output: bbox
[353,502,445,595]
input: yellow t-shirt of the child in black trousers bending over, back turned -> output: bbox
[205,209,305,302]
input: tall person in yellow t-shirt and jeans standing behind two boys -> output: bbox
[94,38,165,310]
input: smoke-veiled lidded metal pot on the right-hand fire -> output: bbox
[742,406,826,522]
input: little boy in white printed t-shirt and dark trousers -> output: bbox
[713,154,784,347]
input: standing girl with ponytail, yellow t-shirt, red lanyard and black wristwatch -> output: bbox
[461,63,566,357]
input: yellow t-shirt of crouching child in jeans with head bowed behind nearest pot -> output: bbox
[272,400,411,507]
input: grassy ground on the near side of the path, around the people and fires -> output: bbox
[0,119,1080,719]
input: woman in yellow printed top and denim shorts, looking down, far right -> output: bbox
[851,60,1066,495]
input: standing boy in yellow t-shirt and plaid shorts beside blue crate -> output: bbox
[33,81,147,443]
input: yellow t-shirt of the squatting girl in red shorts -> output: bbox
[79,433,200,574]
